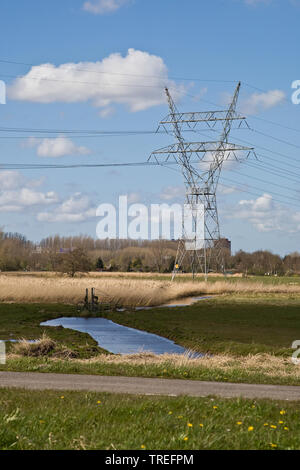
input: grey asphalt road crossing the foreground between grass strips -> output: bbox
[0,372,300,400]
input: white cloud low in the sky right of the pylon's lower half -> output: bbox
[226,193,300,233]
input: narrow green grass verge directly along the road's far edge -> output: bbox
[0,357,300,386]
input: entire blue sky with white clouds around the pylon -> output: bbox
[0,0,300,254]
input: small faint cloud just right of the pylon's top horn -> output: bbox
[240,90,285,114]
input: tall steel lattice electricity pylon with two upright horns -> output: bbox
[149,83,253,280]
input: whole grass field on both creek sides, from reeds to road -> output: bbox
[0,294,300,385]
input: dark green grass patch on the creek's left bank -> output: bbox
[0,304,107,357]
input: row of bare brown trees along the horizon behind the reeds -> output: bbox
[0,232,300,276]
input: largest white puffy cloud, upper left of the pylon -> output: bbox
[8,49,185,114]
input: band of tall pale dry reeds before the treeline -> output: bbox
[0,274,300,307]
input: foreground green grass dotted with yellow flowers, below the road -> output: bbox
[0,389,300,450]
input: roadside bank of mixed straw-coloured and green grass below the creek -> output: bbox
[0,353,300,386]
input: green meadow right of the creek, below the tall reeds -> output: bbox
[103,294,300,356]
